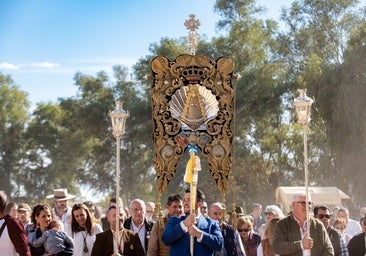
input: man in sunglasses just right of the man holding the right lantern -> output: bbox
[314,205,349,256]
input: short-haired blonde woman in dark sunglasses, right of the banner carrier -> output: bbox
[236,216,261,256]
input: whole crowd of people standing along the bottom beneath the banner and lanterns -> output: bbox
[0,188,366,256]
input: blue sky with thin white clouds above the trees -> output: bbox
[0,0,298,108]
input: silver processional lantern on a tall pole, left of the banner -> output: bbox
[109,101,130,254]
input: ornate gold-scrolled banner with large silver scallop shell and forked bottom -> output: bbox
[151,54,235,194]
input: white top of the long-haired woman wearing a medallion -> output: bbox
[72,224,103,256]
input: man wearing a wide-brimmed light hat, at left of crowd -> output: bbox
[46,188,76,236]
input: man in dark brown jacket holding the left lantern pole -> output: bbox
[91,205,145,256]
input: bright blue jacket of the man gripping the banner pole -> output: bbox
[162,215,224,256]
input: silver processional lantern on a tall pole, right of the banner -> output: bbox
[294,89,314,255]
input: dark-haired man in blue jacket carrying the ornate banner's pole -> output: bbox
[162,186,224,256]
